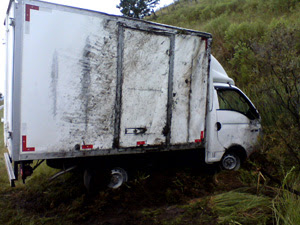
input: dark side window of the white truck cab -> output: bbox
[216,87,259,120]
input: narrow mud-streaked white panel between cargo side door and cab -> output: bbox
[171,35,208,144]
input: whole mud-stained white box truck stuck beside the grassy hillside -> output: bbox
[4,0,260,188]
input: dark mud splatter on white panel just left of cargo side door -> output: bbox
[58,18,117,149]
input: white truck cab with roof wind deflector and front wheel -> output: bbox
[206,56,261,170]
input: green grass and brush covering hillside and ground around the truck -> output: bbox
[0,0,300,224]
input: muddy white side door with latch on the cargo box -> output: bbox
[119,28,171,147]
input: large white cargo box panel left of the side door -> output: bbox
[21,4,117,153]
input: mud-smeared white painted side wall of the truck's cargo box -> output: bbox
[5,2,208,159]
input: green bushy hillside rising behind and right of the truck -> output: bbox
[150,0,300,169]
